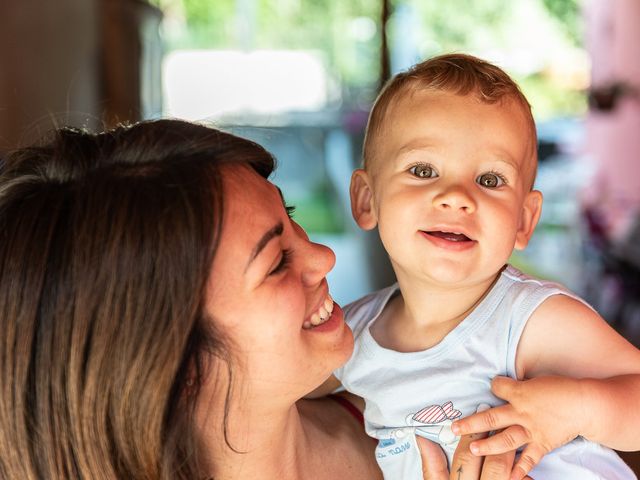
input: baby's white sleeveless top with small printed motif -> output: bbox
[335,266,636,480]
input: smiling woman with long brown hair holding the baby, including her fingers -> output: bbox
[0,120,520,480]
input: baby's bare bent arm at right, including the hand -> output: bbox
[453,295,640,473]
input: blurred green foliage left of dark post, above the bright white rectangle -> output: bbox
[151,0,380,85]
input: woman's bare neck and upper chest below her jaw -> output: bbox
[198,398,381,480]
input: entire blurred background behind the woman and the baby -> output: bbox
[0,0,640,354]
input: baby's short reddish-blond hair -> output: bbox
[363,53,537,185]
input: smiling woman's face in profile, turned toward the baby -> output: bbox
[206,166,353,403]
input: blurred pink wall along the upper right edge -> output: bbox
[583,0,640,242]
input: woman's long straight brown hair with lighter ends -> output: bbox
[0,120,273,479]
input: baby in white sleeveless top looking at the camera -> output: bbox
[316,54,640,480]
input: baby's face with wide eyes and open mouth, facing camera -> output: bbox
[360,91,542,284]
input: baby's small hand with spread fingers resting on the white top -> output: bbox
[451,377,582,480]
